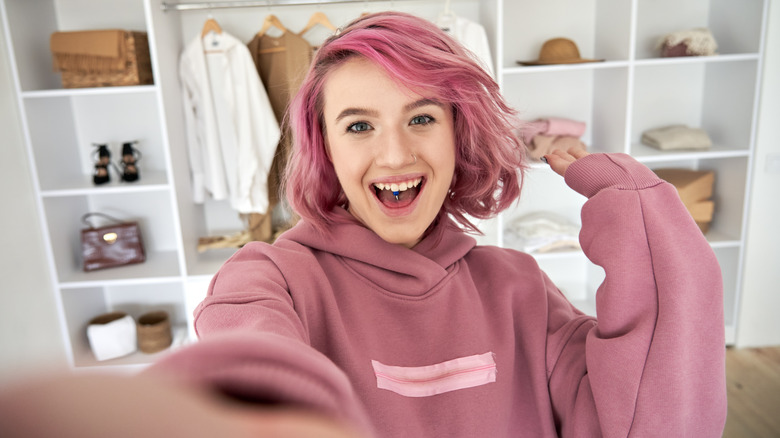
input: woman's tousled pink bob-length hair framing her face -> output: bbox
[285,12,525,233]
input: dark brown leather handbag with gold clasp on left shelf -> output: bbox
[81,213,146,271]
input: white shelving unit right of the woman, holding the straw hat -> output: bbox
[488,0,768,343]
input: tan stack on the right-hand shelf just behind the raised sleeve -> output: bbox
[655,169,715,234]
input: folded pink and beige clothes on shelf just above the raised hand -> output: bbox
[520,117,585,160]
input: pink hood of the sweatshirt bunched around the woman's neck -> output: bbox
[277,207,476,297]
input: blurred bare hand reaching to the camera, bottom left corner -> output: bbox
[0,374,358,438]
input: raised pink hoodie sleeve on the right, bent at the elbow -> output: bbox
[547,154,726,437]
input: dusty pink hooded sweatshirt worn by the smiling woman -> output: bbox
[150,154,726,438]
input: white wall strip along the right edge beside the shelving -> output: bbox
[737,1,780,347]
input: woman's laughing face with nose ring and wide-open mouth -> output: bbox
[323,58,455,248]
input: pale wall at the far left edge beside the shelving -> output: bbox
[0,21,66,384]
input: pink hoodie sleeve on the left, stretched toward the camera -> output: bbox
[146,243,372,436]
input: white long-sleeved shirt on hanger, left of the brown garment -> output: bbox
[179,32,280,213]
